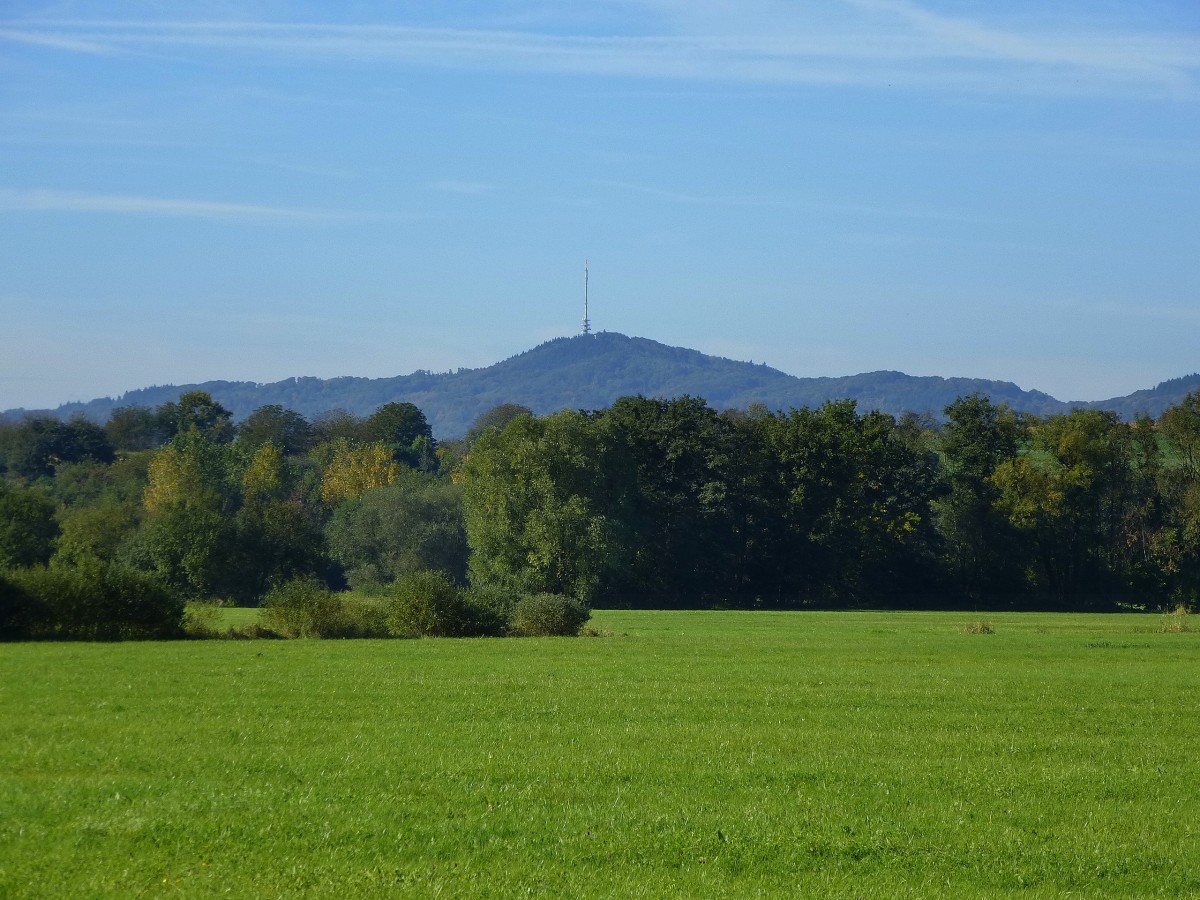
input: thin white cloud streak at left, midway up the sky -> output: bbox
[0,190,347,222]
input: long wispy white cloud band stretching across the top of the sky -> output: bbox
[0,7,1200,96]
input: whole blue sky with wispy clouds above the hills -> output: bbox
[0,0,1200,408]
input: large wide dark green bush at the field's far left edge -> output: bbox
[8,558,184,641]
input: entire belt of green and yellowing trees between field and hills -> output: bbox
[0,391,1200,636]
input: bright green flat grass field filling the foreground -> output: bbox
[0,612,1200,898]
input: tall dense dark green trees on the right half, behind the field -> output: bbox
[462,395,1200,610]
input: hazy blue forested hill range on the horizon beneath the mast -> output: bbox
[5,332,1200,438]
